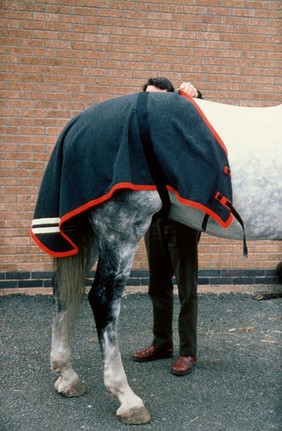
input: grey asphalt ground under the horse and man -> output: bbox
[0,293,282,431]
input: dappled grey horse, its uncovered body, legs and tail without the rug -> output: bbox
[38,95,282,424]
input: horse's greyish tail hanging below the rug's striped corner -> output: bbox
[53,220,95,315]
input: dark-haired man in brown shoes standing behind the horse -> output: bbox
[133,77,202,376]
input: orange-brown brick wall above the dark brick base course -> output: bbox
[0,0,282,288]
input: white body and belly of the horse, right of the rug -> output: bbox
[170,99,282,239]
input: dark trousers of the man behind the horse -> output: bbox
[145,218,200,356]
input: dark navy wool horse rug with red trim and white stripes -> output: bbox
[31,92,233,257]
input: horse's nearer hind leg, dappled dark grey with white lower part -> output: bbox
[89,194,160,424]
